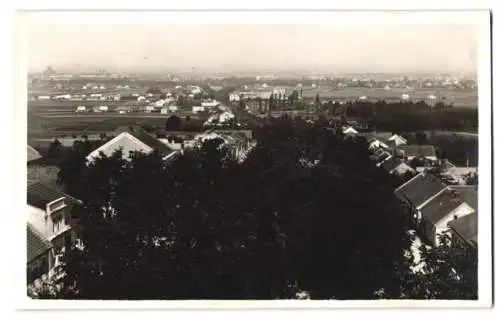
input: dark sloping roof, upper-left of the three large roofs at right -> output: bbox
[394,173,446,207]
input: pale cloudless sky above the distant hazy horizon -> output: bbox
[27,23,477,73]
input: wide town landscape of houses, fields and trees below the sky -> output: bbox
[26,19,480,300]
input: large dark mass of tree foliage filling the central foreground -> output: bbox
[49,119,476,299]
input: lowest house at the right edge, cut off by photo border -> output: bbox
[448,211,477,251]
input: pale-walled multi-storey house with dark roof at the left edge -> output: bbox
[27,182,82,265]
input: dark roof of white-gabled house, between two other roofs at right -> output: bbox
[420,190,463,224]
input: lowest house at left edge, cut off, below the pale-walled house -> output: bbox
[26,223,54,283]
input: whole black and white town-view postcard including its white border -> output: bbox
[15,11,492,306]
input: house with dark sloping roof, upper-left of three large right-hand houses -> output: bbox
[394,172,446,226]
